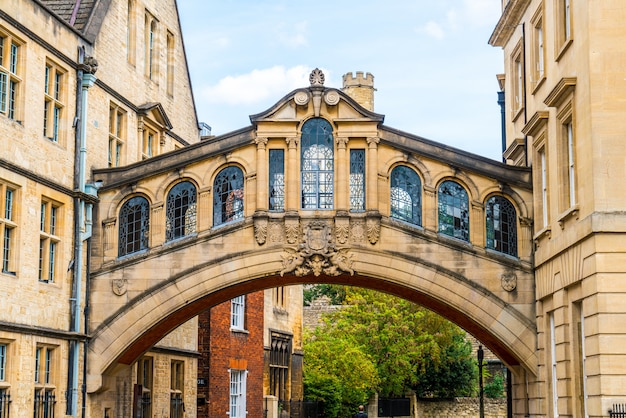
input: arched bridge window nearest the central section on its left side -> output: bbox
[213,166,243,225]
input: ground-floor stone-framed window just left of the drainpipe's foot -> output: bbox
[33,346,56,418]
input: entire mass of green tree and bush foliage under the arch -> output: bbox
[304,287,476,416]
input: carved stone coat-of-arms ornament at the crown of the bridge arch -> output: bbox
[280,221,354,277]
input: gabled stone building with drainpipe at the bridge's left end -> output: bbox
[0,0,200,418]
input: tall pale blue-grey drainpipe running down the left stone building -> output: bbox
[66,47,97,417]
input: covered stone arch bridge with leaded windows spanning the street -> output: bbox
[87,72,537,399]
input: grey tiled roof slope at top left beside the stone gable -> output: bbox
[35,0,111,42]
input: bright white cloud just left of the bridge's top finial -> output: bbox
[202,65,311,105]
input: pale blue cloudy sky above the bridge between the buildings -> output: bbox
[178,0,503,160]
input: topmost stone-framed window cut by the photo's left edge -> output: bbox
[0,27,22,119]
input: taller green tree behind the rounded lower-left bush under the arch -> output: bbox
[304,287,475,406]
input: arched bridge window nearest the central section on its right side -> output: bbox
[389,165,422,225]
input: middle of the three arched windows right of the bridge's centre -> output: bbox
[438,181,469,241]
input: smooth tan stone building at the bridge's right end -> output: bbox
[489,0,626,417]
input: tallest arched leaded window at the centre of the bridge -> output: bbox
[301,118,334,209]
